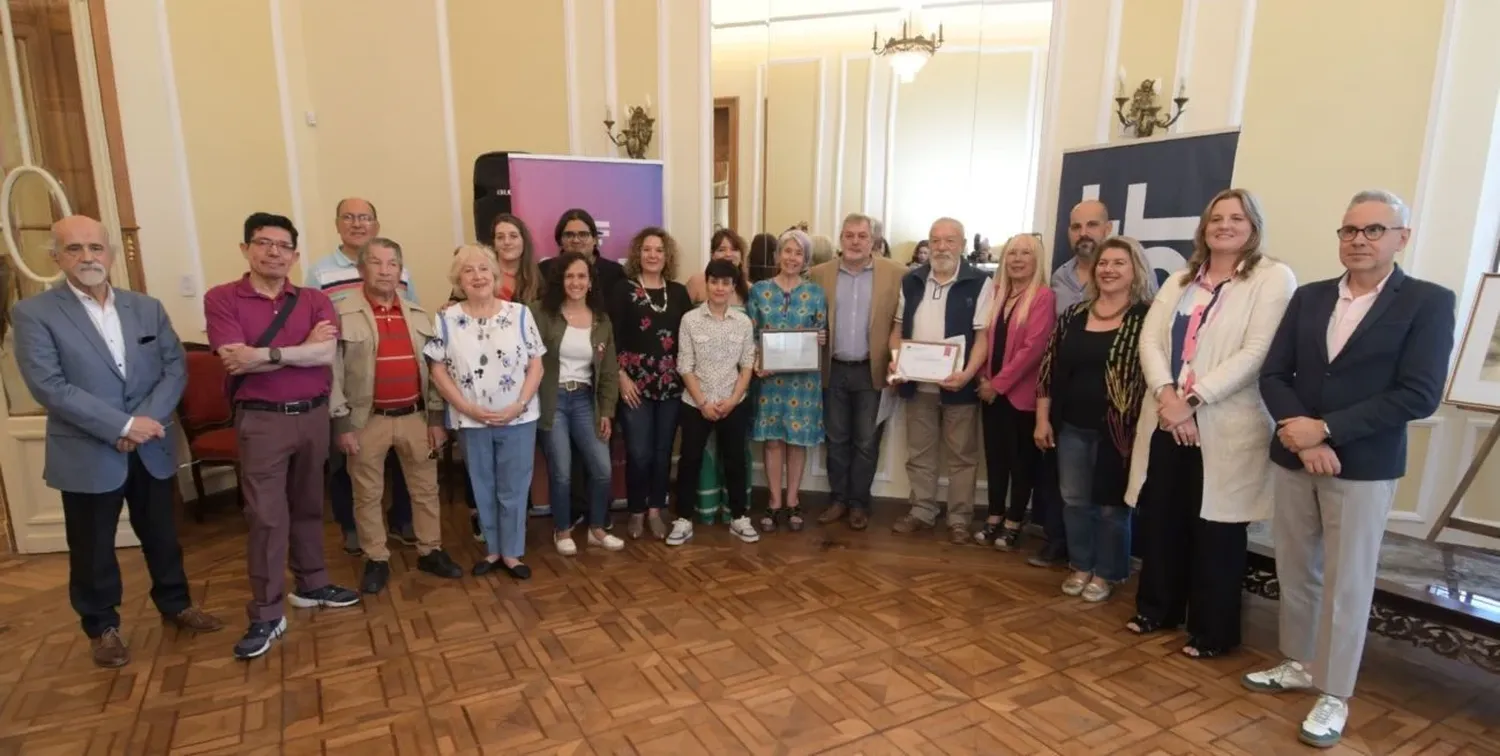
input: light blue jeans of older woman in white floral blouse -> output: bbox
[459,420,537,560]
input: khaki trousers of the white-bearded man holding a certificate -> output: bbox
[906,390,980,527]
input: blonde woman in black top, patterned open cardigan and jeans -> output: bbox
[1034,236,1151,602]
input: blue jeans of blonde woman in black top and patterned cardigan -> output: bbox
[1058,423,1130,582]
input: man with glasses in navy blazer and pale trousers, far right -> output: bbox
[1244,191,1455,747]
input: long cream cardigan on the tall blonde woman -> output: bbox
[1125,258,1298,522]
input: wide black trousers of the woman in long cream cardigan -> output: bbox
[1136,431,1248,650]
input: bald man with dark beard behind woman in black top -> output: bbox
[1026,200,1158,567]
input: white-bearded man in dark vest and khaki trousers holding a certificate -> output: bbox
[890,218,995,545]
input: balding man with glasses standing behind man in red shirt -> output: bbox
[303,197,417,557]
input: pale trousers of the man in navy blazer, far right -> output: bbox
[1271,465,1397,698]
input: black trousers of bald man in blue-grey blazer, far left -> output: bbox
[63,453,192,638]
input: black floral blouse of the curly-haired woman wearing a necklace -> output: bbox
[609,279,693,401]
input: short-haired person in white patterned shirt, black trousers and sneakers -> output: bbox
[666,260,761,546]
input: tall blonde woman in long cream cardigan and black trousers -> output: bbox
[1125,189,1298,659]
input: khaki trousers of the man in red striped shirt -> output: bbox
[348,413,443,561]
